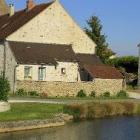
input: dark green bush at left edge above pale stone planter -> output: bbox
[0,75,10,101]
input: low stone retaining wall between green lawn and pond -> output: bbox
[0,114,73,133]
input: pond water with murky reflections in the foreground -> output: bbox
[0,117,140,140]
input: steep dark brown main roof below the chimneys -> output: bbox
[0,2,53,40]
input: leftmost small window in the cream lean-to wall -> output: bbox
[24,66,32,79]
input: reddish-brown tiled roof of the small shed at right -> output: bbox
[84,65,124,79]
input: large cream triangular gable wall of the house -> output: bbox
[7,1,96,54]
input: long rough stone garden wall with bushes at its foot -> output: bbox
[17,79,123,97]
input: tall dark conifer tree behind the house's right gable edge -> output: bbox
[85,16,114,63]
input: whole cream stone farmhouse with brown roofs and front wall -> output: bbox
[0,0,125,96]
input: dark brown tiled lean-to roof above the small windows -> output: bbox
[9,42,77,64]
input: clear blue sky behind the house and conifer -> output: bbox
[7,0,140,55]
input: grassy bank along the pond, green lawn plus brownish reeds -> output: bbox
[0,100,140,122]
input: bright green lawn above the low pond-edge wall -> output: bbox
[0,103,63,121]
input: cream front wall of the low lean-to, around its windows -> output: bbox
[16,62,80,82]
